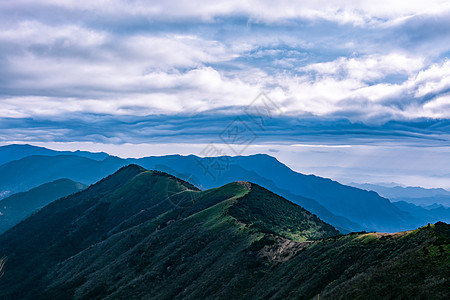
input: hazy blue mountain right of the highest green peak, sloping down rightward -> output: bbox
[134,154,422,232]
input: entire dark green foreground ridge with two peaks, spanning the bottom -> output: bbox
[0,165,450,299]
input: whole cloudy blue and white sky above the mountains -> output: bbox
[0,0,450,186]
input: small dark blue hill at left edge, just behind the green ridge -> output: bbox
[0,179,87,234]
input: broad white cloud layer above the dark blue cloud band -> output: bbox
[0,0,450,120]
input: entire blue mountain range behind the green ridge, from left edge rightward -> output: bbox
[0,146,426,233]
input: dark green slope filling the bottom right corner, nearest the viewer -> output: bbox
[252,222,450,299]
